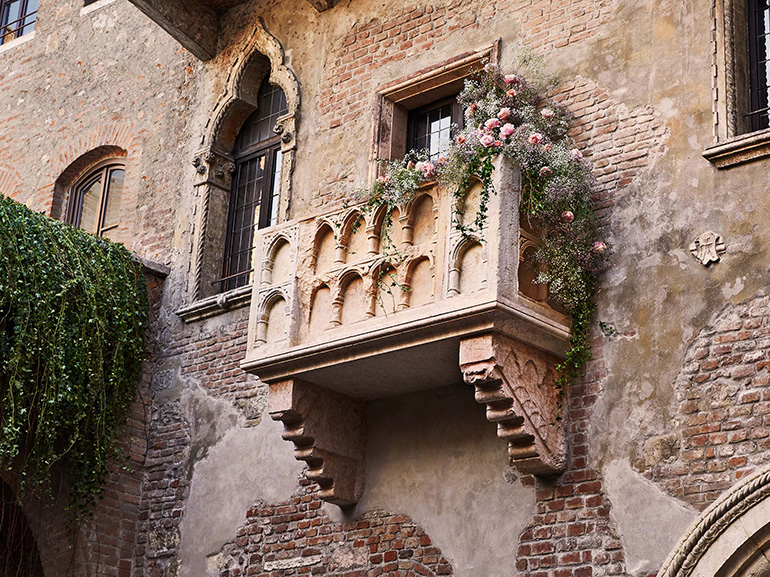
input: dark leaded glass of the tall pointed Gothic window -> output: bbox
[222,77,288,290]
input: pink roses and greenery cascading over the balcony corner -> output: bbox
[367,64,609,396]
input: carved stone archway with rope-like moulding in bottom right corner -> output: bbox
[658,466,770,577]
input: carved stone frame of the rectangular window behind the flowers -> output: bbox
[369,39,500,182]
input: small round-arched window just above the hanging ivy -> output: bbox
[67,161,126,236]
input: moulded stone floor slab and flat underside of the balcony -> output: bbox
[242,302,569,400]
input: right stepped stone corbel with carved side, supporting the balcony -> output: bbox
[460,333,567,475]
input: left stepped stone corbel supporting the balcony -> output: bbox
[268,379,366,506]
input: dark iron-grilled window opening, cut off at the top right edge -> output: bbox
[745,0,770,131]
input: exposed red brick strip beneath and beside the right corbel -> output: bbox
[516,341,625,577]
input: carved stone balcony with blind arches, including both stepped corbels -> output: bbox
[243,163,569,504]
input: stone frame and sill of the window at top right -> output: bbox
[703,0,770,168]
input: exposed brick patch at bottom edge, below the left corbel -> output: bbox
[213,479,453,577]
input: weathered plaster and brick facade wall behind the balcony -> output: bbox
[0,0,770,577]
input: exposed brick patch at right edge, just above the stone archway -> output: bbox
[638,296,770,510]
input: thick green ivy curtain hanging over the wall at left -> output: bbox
[0,196,149,513]
